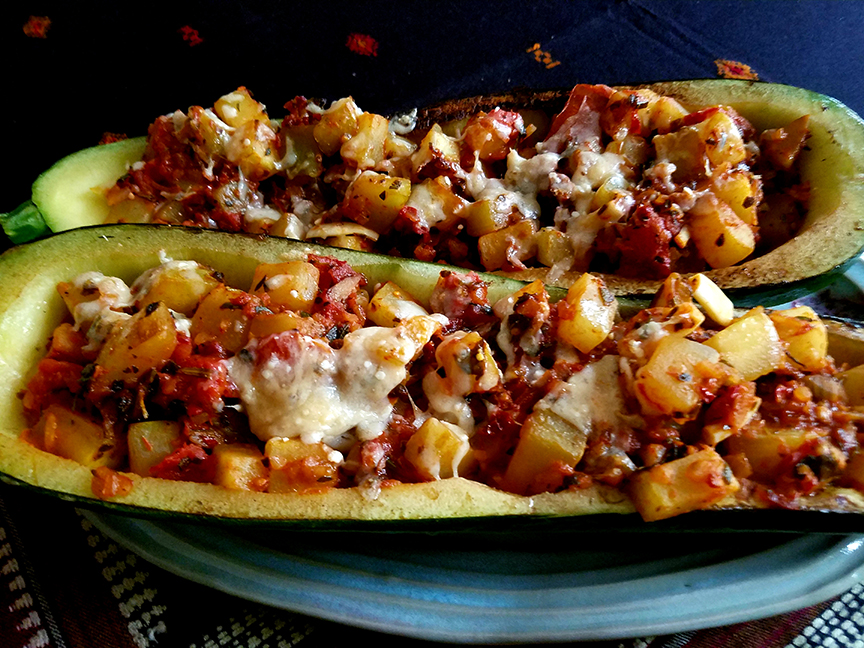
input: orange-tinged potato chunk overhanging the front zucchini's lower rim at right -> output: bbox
[629,448,740,522]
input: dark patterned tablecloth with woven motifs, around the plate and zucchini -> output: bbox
[0,0,864,648]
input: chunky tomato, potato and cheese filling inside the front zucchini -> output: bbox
[21,255,864,520]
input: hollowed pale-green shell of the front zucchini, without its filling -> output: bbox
[0,225,864,530]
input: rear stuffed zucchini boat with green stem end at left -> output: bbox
[6,80,864,304]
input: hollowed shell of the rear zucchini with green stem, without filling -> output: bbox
[0,79,864,306]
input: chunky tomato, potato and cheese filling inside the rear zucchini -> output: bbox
[101,85,809,280]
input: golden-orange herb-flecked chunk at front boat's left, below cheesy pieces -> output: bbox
[93,303,177,392]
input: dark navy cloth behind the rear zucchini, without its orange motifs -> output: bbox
[0,0,864,211]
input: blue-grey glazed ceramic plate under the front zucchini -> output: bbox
[85,512,864,643]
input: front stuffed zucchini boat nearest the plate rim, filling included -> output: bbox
[0,225,864,521]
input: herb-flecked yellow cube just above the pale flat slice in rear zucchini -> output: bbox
[342,171,411,233]
